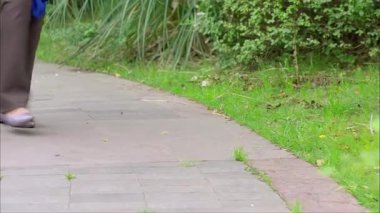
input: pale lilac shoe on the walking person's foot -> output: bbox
[0,108,35,128]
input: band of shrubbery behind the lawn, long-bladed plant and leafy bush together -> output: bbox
[49,0,380,67]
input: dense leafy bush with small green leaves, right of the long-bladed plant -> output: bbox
[200,0,380,66]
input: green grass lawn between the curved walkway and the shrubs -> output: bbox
[38,31,379,212]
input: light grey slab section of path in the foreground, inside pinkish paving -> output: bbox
[2,162,285,212]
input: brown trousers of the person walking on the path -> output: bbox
[0,0,42,113]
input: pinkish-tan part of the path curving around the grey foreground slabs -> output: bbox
[0,63,368,212]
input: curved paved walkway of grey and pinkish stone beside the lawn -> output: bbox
[0,63,365,212]
